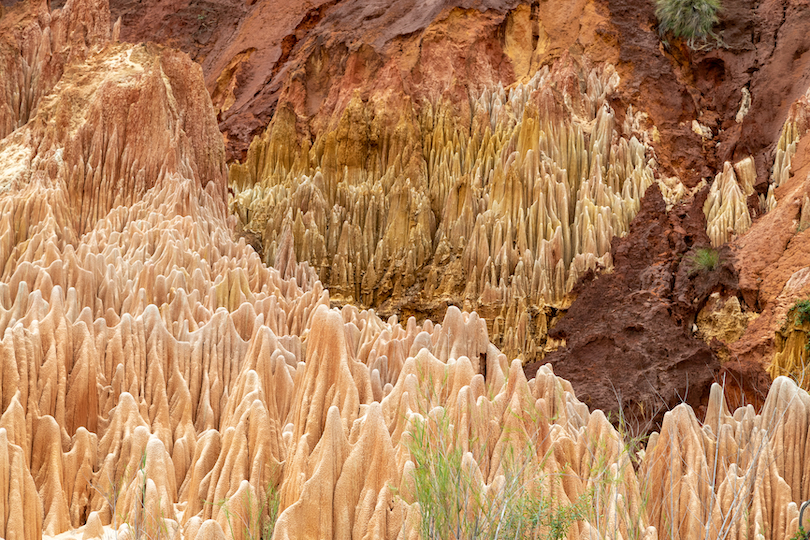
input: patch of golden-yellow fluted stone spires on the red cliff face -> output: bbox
[231,57,654,360]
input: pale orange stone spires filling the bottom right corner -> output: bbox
[641,377,810,538]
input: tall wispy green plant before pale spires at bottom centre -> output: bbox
[394,362,593,540]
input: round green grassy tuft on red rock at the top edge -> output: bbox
[655,0,720,49]
